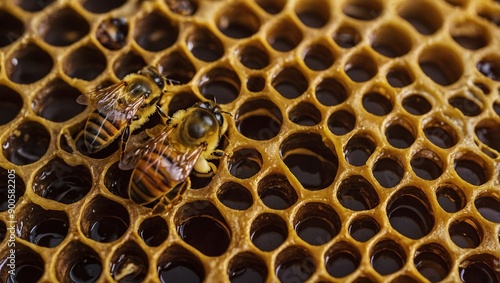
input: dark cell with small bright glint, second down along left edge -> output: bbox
[5,43,54,84]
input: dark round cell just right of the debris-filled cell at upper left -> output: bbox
[134,11,179,52]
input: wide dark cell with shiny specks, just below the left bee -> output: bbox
[33,158,92,204]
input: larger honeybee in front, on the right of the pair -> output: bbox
[119,101,229,213]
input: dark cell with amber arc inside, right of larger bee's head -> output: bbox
[235,99,283,140]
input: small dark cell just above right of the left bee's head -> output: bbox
[158,51,196,84]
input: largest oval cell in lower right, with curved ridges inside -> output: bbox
[386,187,434,239]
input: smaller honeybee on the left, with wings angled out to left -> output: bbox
[76,66,170,160]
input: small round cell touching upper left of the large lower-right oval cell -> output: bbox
[372,156,405,188]
